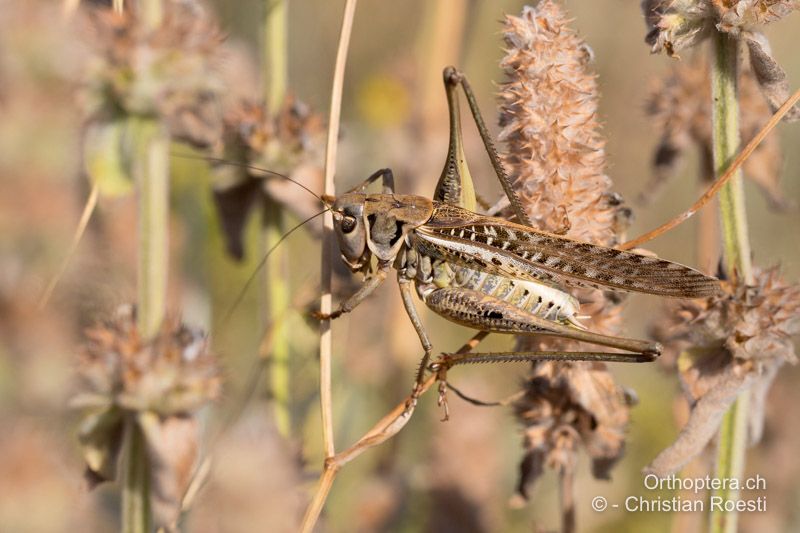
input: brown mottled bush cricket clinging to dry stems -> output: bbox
[316,67,719,398]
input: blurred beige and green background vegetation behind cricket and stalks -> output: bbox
[0,0,800,532]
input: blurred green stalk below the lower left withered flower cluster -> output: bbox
[122,417,153,533]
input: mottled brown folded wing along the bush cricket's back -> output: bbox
[415,203,719,298]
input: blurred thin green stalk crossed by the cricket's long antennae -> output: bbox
[261,0,291,437]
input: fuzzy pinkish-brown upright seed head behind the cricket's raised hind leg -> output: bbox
[499,1,618,244]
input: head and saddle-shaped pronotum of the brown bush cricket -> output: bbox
[331,192,433,272]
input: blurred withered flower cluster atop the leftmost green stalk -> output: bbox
[85,0,223,147]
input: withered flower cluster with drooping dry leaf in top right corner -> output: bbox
[642,0,800,120]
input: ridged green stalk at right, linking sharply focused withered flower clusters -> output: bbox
[710,33,753,533]
